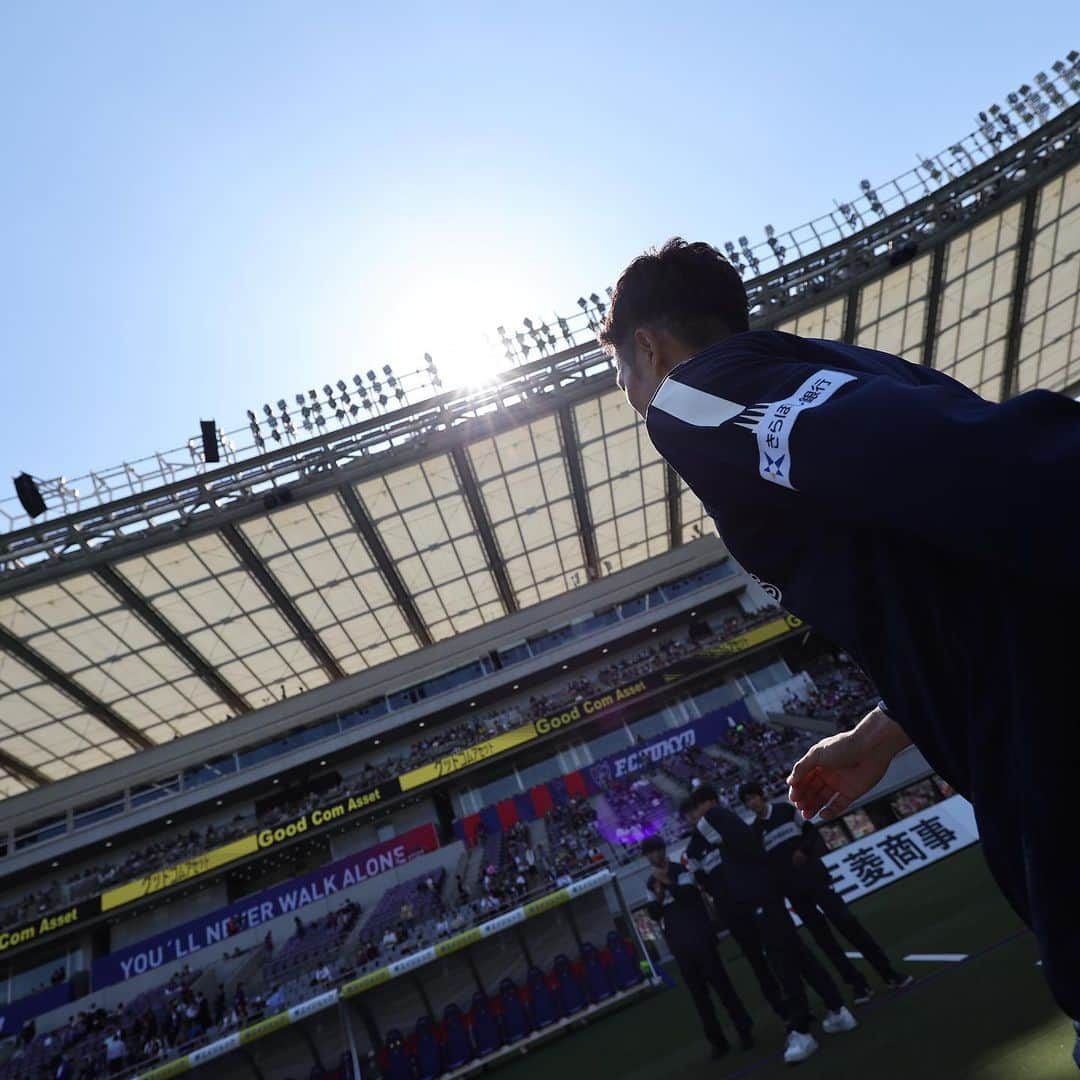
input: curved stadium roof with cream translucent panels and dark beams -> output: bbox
[0,71,1080,796]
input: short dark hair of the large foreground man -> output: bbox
[597,237,750,351]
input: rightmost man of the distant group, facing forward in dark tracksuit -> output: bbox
[739,783,912,1005]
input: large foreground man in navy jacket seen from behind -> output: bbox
[599,240,1080,1064]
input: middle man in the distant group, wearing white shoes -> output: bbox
[688,784,858,1064]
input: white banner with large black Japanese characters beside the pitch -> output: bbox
[822,795,978,902]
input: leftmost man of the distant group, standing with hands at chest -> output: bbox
[642,836,754,1057]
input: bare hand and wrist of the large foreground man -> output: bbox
[787,708,912,821]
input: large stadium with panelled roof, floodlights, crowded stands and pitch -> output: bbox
[0,52,1080,1080]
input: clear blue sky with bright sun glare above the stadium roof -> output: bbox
[0,0,1080,496]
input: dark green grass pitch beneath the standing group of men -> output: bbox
[499,847,1080,1080]
